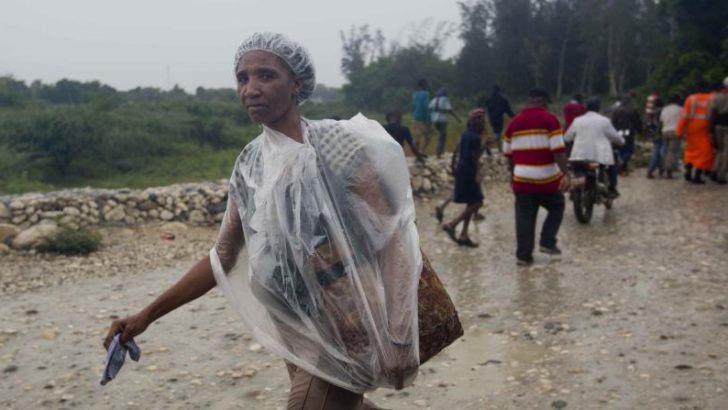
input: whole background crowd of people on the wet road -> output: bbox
[398,77,728,265]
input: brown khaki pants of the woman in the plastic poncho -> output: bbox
[286,362,379,410]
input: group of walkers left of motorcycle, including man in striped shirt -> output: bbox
[392,80,570,265]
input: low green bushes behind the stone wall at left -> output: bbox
[0,77,370,194]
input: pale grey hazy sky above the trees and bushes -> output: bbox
[0,0,460,91]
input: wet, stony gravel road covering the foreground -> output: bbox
[0,168,728,410]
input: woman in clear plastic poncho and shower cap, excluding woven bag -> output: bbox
[104,33,423,410]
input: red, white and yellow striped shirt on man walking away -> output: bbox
[503,107,566,193]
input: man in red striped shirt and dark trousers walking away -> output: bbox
[503,88,570,266]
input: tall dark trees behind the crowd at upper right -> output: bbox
[341,0,728,110]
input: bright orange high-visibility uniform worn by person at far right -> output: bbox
[675,93,713,171]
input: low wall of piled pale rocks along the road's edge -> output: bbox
[0,154,508,253]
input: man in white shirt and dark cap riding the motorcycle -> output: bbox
[564,97,624,197]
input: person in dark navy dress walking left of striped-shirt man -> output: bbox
[442,109,485,248]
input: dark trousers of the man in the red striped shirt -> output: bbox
[516,192,566,260]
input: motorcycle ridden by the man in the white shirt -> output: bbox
[570,161,614,224]
